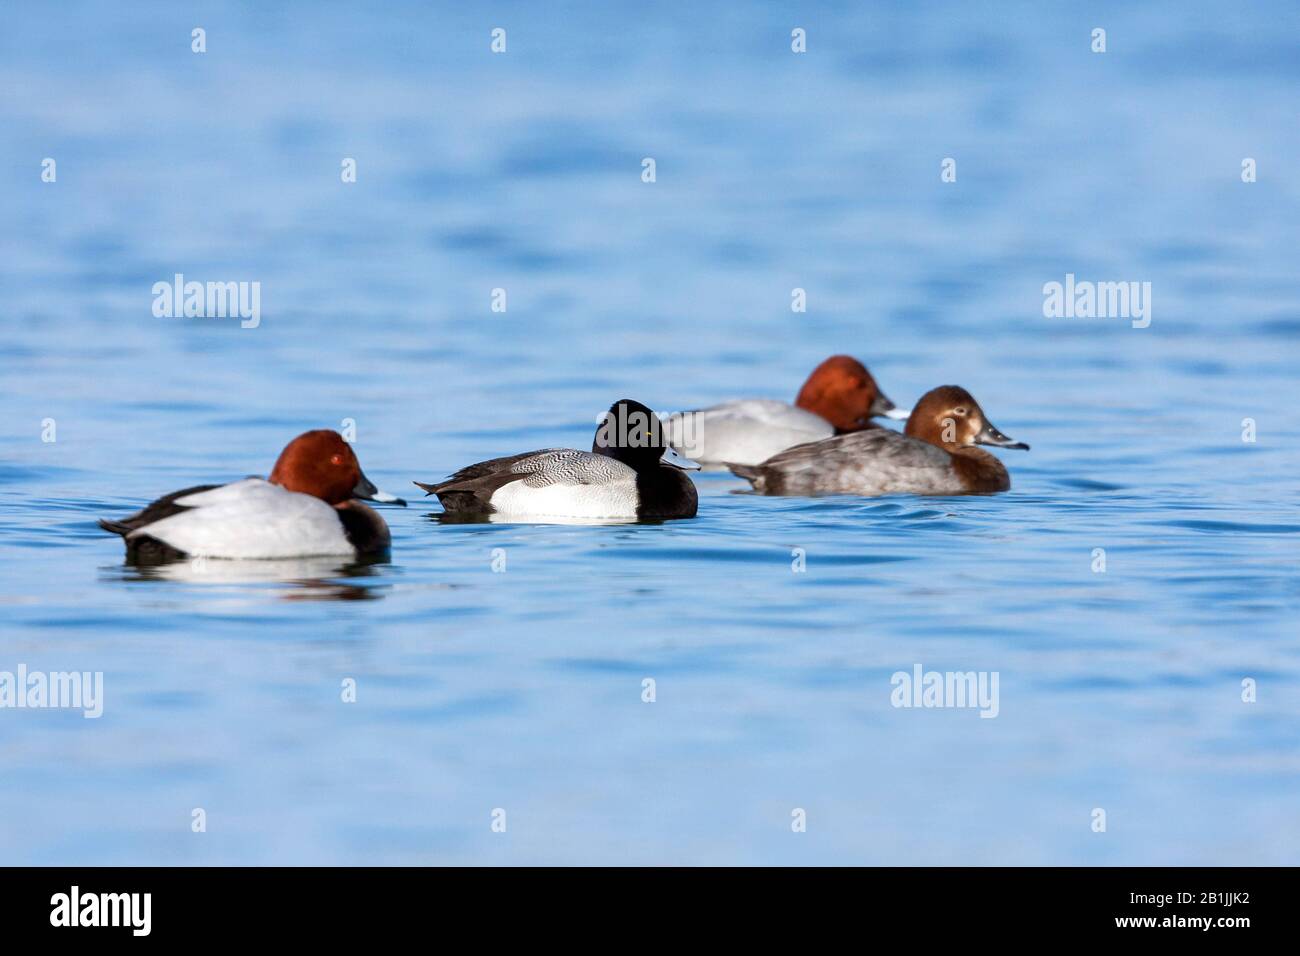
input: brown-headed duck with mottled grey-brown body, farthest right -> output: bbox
[731,385,1030,497]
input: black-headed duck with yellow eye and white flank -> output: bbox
[415,398,699,520]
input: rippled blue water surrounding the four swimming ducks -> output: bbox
[0,3,1300,864]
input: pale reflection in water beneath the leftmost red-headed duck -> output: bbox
[105,555,389,601]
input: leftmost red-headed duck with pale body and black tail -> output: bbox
[99,429,406,564]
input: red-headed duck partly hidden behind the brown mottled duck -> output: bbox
[666,355,907,471]
